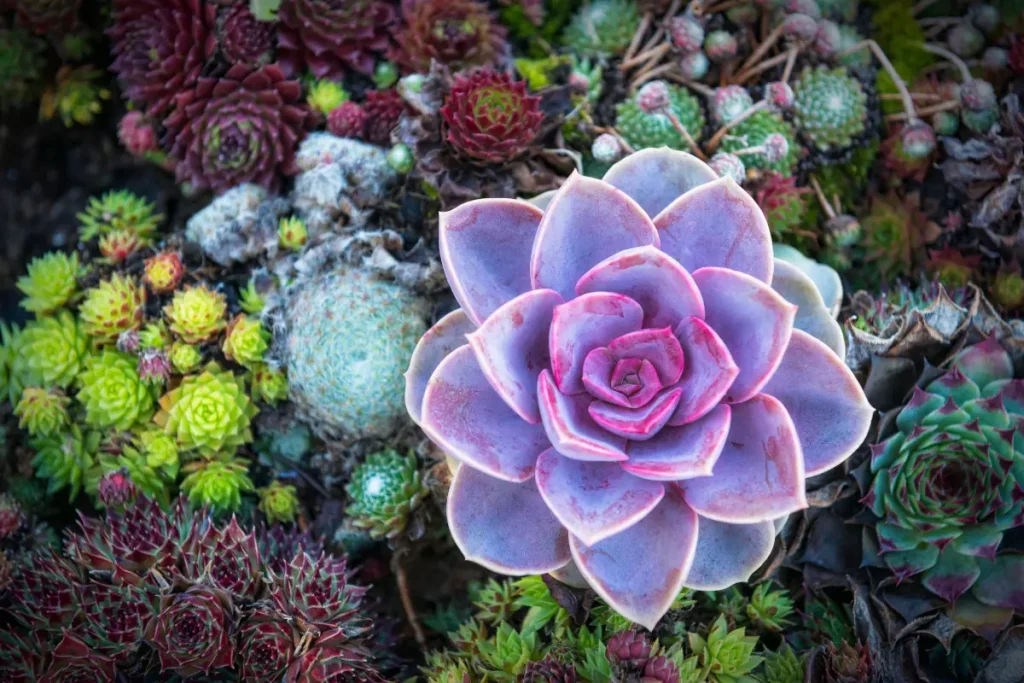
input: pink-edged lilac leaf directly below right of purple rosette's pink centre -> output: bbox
[622,403,732,481]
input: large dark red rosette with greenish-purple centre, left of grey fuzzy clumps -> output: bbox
[164,65,310,193]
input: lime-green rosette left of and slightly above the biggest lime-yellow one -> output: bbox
[77,349,154,430]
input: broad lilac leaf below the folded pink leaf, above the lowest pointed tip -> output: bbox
[537,449,665,546]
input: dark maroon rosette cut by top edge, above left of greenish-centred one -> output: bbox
[109,0,217,116]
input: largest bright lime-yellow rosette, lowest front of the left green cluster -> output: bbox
[154,364,259,457]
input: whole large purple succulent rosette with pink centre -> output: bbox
[407,150,872,628]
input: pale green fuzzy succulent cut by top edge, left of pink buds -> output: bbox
[562,0,640,57]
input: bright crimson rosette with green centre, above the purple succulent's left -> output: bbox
[441,69,544,164]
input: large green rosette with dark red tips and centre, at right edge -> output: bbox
[865,338,1024,607]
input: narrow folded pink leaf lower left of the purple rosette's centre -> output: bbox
[537,371,626,462]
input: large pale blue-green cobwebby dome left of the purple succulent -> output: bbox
[283,267,426,437]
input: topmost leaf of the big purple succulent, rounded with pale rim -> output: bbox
[604,147,718,216]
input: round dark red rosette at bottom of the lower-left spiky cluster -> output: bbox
[145,584,234,677]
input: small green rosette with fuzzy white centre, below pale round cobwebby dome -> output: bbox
[346,450,427,539]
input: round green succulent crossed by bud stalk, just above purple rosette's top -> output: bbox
[615,85,705,151]
